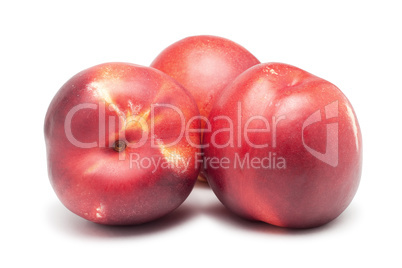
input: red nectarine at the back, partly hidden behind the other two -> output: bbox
[151,35,260,180]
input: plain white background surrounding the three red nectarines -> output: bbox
[0,0,402,268]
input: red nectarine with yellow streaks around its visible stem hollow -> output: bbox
[45,63,200,225]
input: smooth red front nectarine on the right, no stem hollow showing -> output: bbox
[204,63,362,228]
